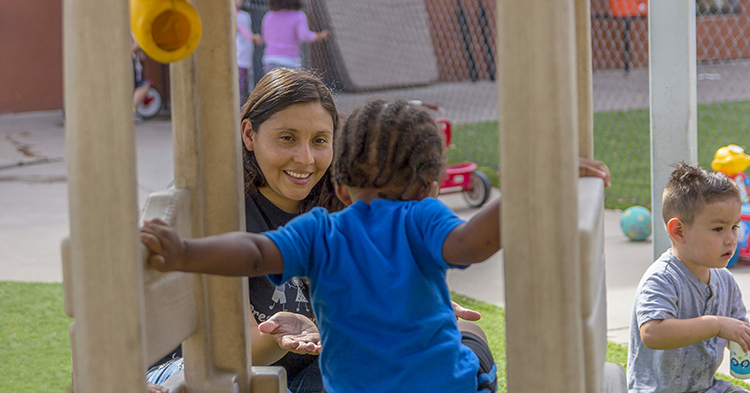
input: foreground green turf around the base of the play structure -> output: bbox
[0,281,750,393]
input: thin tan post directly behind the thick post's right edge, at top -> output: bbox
[575,0,594,158]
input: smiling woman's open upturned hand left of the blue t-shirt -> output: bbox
[258,312,322,355]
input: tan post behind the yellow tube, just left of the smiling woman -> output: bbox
[171,0,251,392]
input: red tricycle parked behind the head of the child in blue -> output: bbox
[435,118,492,207]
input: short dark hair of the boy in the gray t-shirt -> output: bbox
[661,162,741,225]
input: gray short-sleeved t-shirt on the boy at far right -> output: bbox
[628,250,747,393]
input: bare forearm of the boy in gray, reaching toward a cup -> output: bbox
[640,315,750,351]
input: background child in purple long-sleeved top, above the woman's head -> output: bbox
[262,0,331,72]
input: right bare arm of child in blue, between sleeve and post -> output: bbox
[443,198,501,266]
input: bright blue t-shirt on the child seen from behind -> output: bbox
[265,198,479,393]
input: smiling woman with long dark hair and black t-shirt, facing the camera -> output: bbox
[147,68,344,393]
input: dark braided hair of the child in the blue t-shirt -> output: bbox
[333,100,444,200]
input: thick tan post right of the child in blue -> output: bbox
[497,0,585,393]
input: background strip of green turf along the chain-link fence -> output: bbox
[447,101,750,209]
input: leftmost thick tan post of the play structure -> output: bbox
[63,0,146,393]
